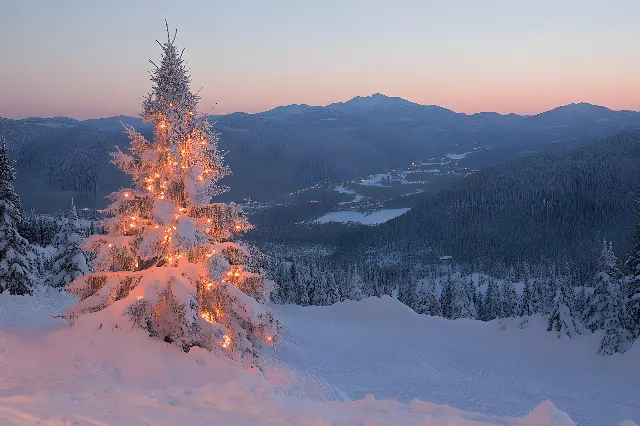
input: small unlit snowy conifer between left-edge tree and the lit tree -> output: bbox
[49,200,89,287]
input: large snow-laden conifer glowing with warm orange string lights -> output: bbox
[65,27,282,365]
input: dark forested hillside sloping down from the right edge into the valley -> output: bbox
[343,132,640,273]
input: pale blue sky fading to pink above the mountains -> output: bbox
[0,0,640,119]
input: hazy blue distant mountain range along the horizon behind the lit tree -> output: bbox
[0,94,640,210]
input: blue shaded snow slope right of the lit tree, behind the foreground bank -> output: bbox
[275,297,640,426]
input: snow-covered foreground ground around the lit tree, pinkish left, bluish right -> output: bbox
[0,290,640,426]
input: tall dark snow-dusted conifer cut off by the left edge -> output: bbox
[0,138,33,295]
